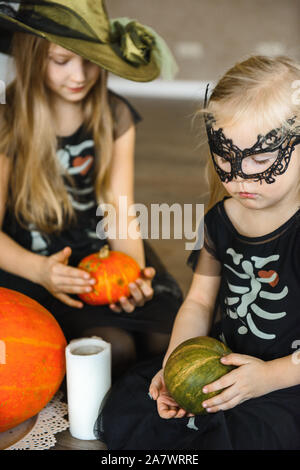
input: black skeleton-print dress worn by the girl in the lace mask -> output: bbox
[98,198,300,450]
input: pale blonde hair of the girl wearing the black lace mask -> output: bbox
[198,56,300,212]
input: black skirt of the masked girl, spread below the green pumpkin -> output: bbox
[96,357,300,450]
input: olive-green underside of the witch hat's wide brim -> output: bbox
[0,13,160,82]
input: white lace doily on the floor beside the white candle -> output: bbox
[7,392,69,450]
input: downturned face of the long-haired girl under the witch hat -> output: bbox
[46,44,101,103]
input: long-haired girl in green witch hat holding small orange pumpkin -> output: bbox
[0,0,181,375]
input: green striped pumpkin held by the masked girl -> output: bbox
[164,336,234,414]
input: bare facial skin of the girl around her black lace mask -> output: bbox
[222,123,300,209]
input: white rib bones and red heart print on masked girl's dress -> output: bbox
[224,248,288,339]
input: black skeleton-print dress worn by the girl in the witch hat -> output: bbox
[0,91,182,340]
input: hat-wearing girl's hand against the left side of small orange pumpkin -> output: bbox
[40,247,95,308]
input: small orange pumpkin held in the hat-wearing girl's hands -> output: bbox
[78,245,141,305]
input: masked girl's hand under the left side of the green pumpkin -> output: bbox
[149,369,194,419]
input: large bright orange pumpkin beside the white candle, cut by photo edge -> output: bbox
[0,287,66,432]
